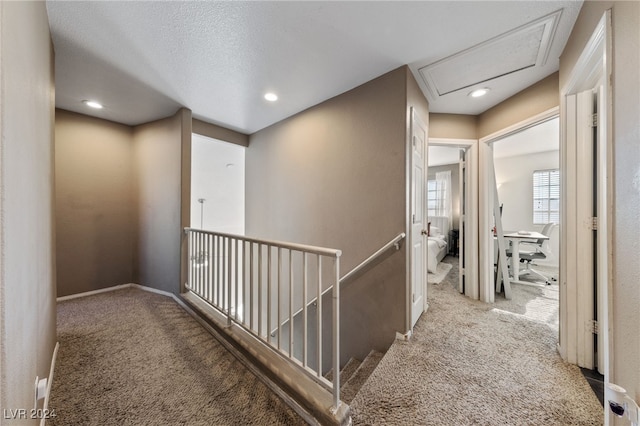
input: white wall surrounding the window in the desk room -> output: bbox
[494,150,560,262]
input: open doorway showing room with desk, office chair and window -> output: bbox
[487,115,560,330]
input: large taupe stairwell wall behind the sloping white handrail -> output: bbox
[246,67,426,363]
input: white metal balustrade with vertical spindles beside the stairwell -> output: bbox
[184,228,341,411]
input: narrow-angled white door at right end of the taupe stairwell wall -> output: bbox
[410,109,427,328]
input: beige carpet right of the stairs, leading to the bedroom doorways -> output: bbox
[351,258,603,426]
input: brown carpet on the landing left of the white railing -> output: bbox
[48,289,304,425]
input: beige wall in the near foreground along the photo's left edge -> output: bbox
[0,2,56,425]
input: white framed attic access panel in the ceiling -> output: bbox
[419,10,562,99]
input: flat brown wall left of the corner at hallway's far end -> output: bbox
[55,110,136,296]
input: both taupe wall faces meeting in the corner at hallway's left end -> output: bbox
[56,109,191,296]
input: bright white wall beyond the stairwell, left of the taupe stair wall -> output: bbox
[191,133,245,235]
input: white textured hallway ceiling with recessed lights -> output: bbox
[47,1,582,134]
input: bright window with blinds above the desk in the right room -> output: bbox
[533,169,560,225]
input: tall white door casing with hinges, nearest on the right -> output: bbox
[559,11,613,396]
